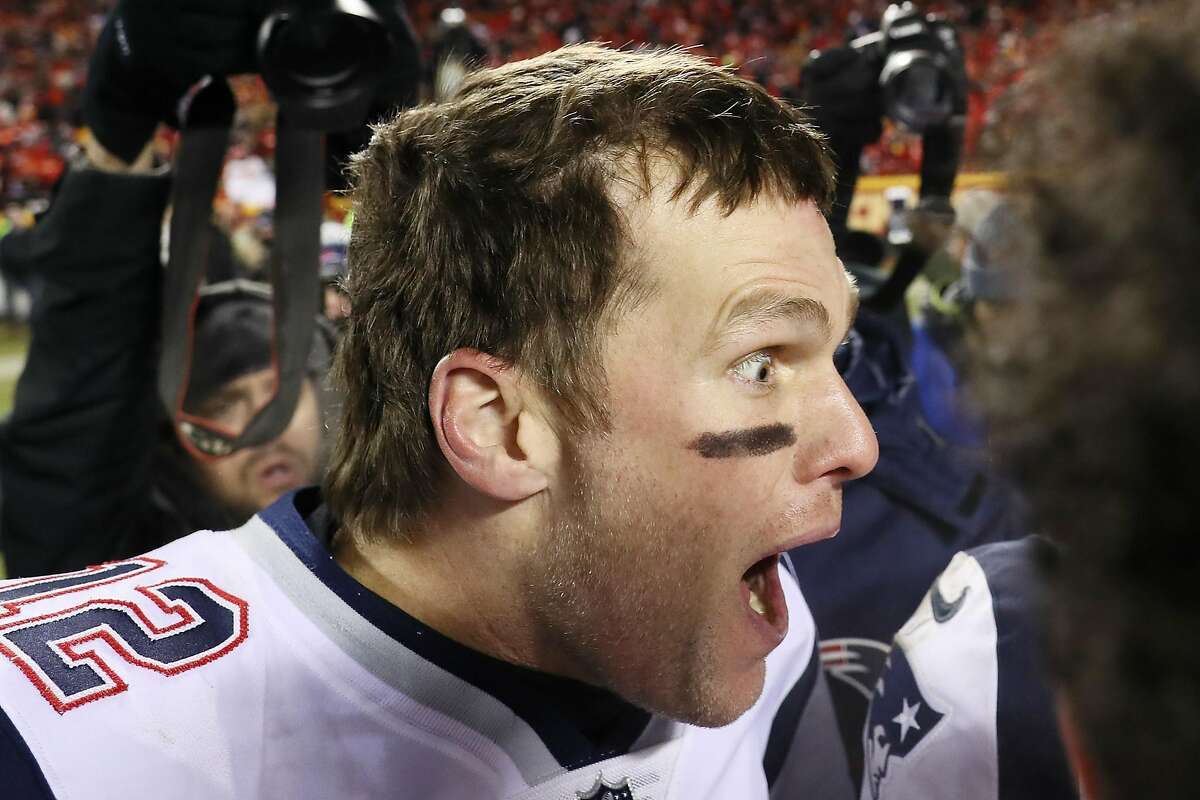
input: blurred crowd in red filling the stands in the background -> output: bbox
[0,0,1109,245]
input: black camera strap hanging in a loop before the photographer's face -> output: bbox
[158,125,324,459]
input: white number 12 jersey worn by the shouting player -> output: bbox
[0,491,851,800]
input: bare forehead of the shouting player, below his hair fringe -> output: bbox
[628,193,851,333]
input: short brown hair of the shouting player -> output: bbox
[325,44,833,535]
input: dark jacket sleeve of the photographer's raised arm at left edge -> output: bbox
[0,169,169,576]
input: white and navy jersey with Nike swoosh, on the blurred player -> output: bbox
[860,536,1078,800]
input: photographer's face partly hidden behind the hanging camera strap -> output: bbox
[197,369,320,518]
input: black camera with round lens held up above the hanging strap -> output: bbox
[257,0,396,131]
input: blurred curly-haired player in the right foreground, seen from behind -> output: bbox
[863,2,1200,800]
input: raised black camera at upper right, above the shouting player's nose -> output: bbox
[850,2,966,133]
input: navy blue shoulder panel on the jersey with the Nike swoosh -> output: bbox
[968,536,1079,800]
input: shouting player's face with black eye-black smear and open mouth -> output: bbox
[526,191,877,726]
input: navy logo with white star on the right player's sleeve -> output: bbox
[864,646,946,800]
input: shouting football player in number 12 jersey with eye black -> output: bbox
[0,40,877,800]
